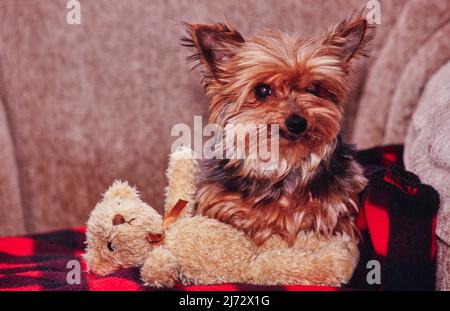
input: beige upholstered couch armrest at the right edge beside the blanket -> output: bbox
[404,61,450,290]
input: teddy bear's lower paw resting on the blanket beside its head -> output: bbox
[141,247,178,288]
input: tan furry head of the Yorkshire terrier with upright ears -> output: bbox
[183,18,371,177]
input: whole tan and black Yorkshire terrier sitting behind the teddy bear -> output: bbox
[182,17,371,256]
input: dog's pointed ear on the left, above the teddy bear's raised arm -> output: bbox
[181,24,245,75]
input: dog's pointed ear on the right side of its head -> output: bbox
[324,18,373,63]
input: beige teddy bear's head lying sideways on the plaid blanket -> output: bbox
[84,181,162,275]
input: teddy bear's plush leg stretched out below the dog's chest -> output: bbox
[250,238,359,286]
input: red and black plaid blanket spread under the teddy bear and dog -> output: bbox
[0,146,435,291]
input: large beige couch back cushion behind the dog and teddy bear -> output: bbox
[0,0,372,232]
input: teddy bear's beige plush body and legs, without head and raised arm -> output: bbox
[141,216,358,287]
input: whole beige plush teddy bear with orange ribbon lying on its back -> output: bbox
[85,149,359,287]
